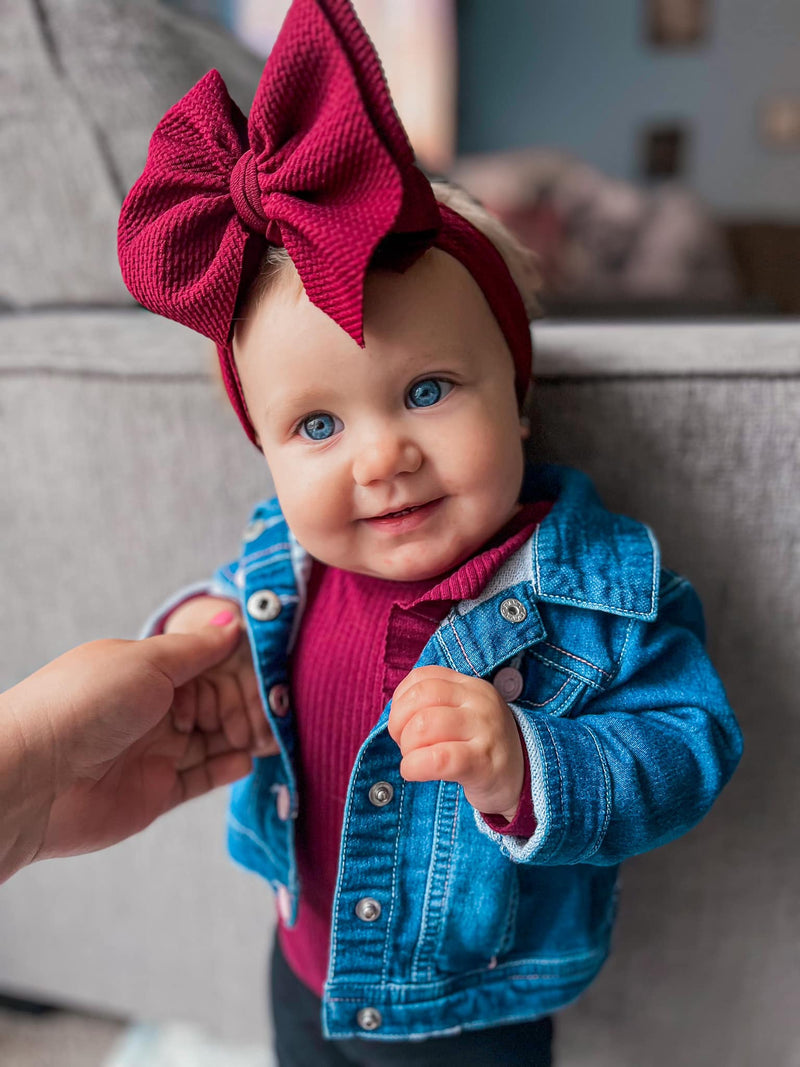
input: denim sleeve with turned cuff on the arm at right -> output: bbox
[478,579,741,864]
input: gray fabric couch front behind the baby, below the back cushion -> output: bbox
[0,310,800,1067]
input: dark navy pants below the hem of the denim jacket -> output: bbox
[271,938,553,1067]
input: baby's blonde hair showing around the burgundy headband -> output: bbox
[240,181,542,322]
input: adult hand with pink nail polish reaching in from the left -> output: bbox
[0,612,251,880]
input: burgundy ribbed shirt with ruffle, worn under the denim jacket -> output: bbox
[278,501,550,997]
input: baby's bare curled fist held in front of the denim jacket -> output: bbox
[388,667,525,821]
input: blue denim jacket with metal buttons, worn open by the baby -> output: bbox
[153,465,741,1040]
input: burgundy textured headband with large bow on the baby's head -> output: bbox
[118,0,531,441]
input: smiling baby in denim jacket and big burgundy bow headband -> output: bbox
[119,0,740,1067]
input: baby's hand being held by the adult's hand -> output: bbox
[164,596,278,755]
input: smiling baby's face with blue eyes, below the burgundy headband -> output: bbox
[234,249,523,580]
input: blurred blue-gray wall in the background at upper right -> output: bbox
[459,0,800,218]
